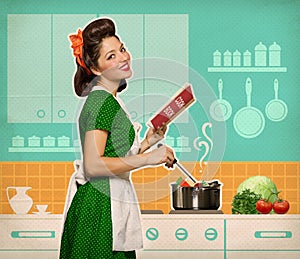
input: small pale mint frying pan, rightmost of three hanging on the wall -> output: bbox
[266,79,288,121]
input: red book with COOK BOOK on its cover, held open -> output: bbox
[150,84,195,129]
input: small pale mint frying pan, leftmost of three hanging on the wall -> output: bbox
[209,79,232,121]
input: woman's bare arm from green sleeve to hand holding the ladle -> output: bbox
[83,130,174,177]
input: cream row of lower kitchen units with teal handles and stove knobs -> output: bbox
[0,214,300,259]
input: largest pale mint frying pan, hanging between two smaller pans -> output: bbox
[233,77,265,138]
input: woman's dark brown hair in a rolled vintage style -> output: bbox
[74,18,127,96]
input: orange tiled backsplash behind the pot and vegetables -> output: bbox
[0,162,300,214]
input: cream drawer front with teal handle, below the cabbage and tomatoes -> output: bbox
[226,215,300,258]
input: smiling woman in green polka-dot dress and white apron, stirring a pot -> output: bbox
[60,19,174,259]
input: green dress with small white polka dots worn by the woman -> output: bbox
[60,90,136,259]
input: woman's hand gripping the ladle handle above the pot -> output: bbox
[147,146,175,168]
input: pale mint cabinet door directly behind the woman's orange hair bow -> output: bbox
[52,14,96,123]
